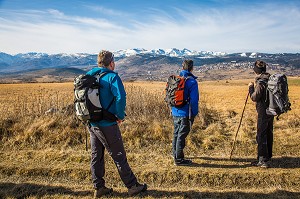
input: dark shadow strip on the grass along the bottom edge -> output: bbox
[0,182,300,199]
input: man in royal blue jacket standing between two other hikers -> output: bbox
[172,60,199,166]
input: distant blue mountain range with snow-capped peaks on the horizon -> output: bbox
[0,48,300,74]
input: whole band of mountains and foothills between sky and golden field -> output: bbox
[0,48,300,82]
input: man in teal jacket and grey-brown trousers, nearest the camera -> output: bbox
[87,50,147,198]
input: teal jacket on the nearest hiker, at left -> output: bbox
[87,67,126,126]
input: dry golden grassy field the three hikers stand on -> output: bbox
[0,78,300,198]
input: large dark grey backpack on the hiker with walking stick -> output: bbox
[266,74,291,119]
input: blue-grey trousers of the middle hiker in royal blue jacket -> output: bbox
[172,116,194,161]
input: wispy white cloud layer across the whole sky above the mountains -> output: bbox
[0,5,300,53]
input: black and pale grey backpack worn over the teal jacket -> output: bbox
[74,72,117,123]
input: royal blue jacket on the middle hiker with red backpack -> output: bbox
[172,70,199,117]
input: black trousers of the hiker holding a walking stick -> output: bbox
[256,114,274,160]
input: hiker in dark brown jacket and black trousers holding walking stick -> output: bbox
[248,60,274,168]
